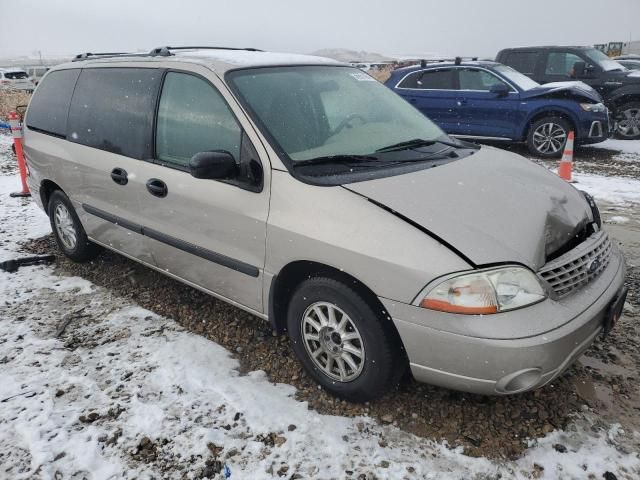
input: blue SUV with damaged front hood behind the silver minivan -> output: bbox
[385,58,612,158]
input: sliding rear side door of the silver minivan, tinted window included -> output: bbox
[65,67,162,265]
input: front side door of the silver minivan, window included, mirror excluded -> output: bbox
[136,67,269,312]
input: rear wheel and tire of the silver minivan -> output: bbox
[47,190,100,262]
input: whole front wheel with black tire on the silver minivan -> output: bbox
[287,277,406,402]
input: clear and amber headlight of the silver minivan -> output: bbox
[419,266,547,315]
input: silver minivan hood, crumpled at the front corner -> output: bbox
[343,147,592,270]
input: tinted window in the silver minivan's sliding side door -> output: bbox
[67,68,161,159]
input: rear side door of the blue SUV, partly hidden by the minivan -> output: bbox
[395,68,460,133]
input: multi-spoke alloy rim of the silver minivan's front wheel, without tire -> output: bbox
[301,302,365,382]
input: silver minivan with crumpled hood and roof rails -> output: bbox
[24,47,626,401]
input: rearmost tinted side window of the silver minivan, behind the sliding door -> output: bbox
[26,69,80,137]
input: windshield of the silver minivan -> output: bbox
[227,66,447,162]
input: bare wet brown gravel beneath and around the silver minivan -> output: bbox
[5,133,640,464]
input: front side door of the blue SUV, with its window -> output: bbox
[455,67,520,139]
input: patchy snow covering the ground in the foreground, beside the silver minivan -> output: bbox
[0,137,640,479]
